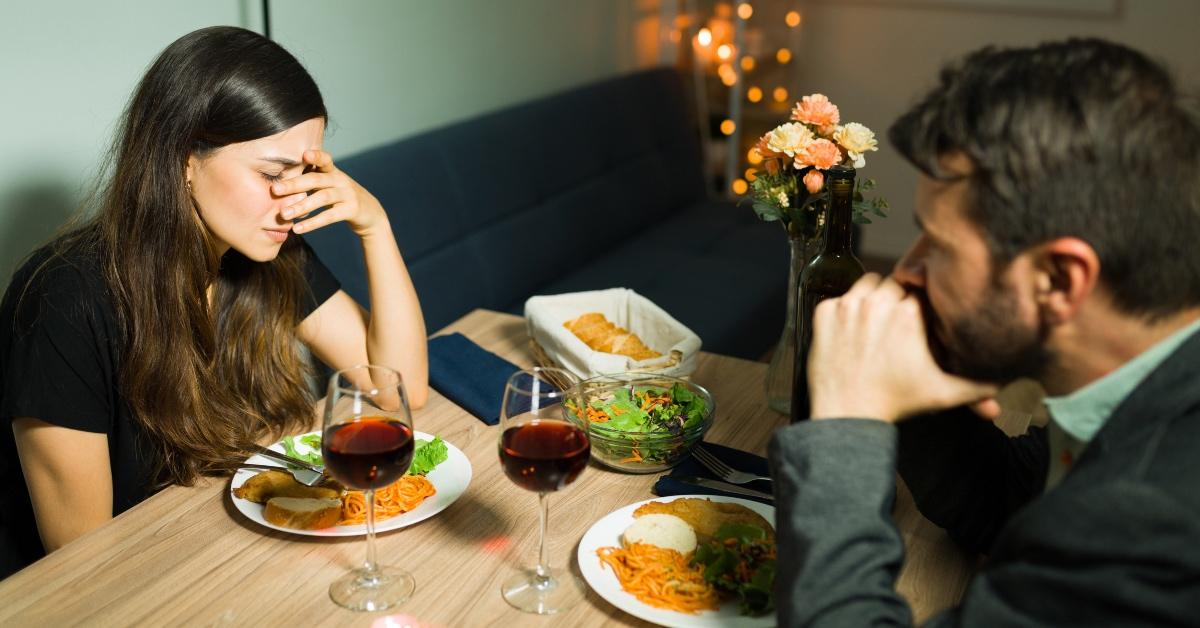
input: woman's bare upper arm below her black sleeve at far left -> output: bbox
[12,417,113,552]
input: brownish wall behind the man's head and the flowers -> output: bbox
[797,0,1200,257]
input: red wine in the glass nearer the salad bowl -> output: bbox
[500,420,592,492]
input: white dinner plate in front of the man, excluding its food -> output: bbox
[576,495,775,628]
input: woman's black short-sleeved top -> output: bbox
[0,240,340,579]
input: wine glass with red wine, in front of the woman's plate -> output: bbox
[320,364,416,611]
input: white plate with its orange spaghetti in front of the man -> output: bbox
[576,495,775,627]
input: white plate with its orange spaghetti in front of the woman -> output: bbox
[229,432,472,537]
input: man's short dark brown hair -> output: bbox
[889,40,1200,319]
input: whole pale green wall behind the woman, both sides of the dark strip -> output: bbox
[0,0,653,295]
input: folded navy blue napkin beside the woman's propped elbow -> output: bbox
[430,334,521,425]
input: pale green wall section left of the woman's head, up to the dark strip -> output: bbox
[0,0,250,289]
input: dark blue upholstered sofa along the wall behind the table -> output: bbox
[306,70,788,358]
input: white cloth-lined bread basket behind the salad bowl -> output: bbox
[524,288,701,379]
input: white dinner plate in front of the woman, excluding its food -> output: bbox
[229,432,470,537]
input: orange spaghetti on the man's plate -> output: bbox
[596,543,721,612]
